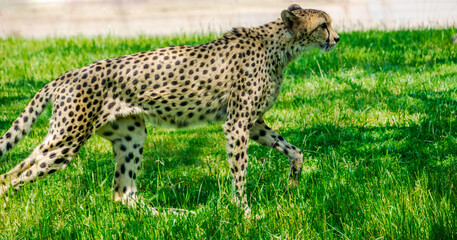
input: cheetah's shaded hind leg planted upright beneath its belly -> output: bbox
[96,116,194,215]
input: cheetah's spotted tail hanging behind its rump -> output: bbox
[0,84,51,157]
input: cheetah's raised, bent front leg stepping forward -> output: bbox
[250,118,303,184]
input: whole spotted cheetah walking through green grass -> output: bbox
[0,4,339,215]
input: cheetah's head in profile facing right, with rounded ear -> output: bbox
[281,4,340,52]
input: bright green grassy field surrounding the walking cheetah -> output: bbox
[0,29,457,239]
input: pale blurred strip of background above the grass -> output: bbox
[0,0,457,38]
